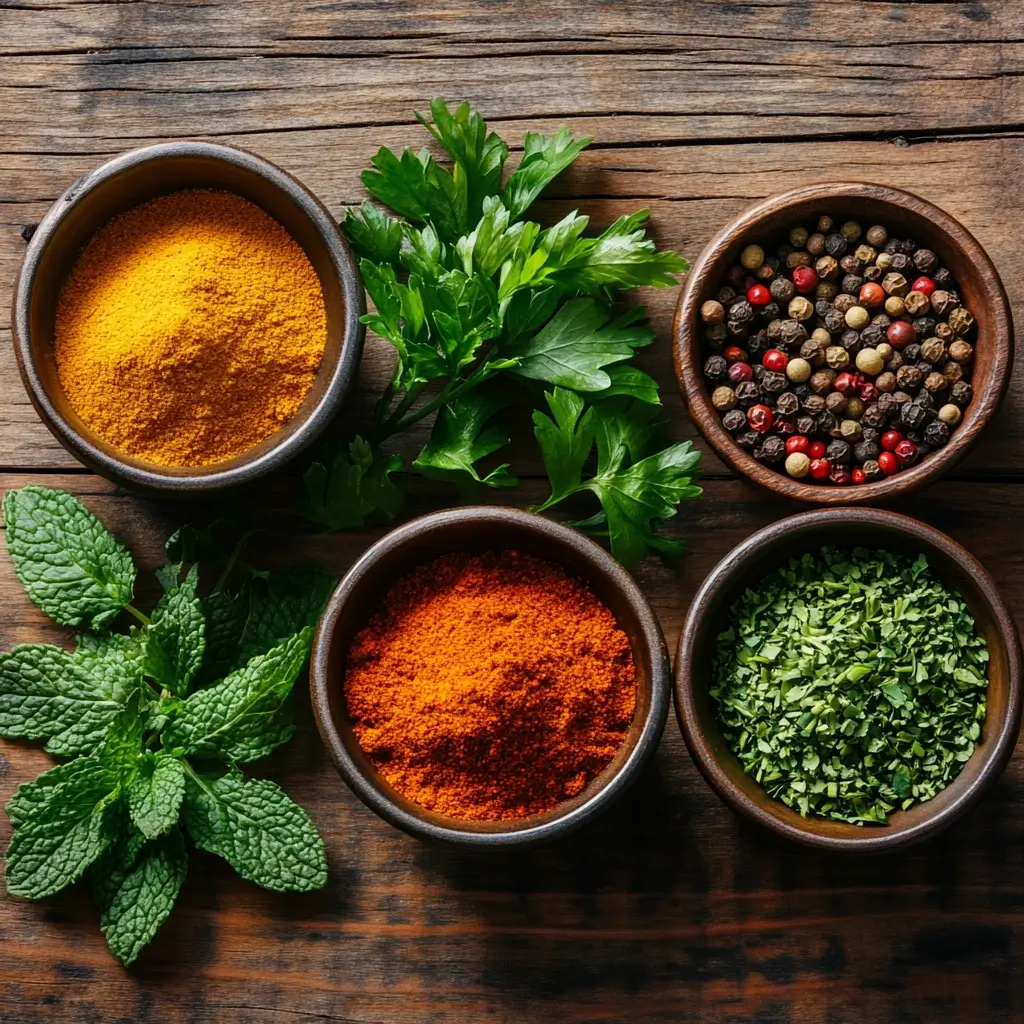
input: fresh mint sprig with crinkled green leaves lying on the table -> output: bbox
[0,486,334,964]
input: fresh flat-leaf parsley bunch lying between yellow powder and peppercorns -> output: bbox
[305,99,700,562]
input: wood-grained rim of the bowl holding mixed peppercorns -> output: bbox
[672,181,1014,507]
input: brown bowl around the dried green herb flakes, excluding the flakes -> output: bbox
[675,508,1021,853]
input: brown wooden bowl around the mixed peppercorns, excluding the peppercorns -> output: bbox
[674,182,1014,505]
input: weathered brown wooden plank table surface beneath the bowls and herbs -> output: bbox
[0,0,1024,1024]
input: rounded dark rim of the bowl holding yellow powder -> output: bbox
[11,139,366,495]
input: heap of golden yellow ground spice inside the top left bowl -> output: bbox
[55,189,327,466]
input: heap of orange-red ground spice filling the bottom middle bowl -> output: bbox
[344,551,636,820]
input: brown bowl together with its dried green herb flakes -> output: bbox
[675,508,1021,853]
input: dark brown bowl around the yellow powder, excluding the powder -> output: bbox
[11,142,366,495]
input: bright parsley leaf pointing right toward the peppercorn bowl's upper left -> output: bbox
[552,210,689,294]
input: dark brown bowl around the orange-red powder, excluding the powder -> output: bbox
[309,507,671,849]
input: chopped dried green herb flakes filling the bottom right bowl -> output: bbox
[711,548,988,824]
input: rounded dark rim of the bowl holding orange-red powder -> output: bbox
[309,505,672,849]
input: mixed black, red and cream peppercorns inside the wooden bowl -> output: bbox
[700,216,975,484]
